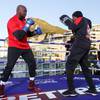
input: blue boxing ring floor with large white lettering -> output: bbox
[0,75,100,100]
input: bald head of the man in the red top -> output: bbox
[16,5,27,20]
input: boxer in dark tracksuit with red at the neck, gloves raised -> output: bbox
[60,11,97,96]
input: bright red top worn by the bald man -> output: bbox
[7,15,30,49]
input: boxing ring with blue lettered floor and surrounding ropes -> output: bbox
[0,40,100,100]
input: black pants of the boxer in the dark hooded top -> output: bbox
[66,39,95,90]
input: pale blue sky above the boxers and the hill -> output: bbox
[0,0,100,39]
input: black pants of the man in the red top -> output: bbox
[1,47,36,82]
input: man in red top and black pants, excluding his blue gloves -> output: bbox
[0,5,40,96]
